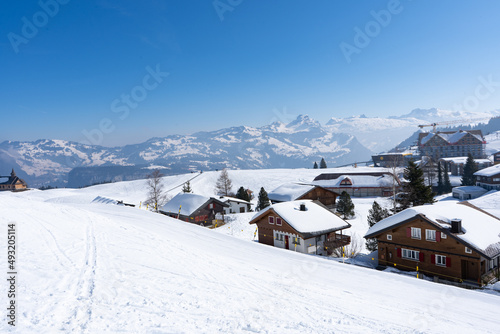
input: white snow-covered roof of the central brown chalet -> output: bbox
[250,200,351,237]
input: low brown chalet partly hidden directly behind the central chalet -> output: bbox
[268,183,339,208]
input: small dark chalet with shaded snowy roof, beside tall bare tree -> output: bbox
[160,193,229,226]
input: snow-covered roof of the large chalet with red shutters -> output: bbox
[365,202,500,257]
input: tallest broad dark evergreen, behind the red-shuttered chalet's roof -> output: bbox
[396,160,435,212]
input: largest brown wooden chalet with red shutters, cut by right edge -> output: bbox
[365,202,500,285]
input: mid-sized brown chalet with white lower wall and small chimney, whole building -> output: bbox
[250,200,351,255]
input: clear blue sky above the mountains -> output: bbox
[0,0,500,146]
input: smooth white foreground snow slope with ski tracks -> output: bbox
[0,188,500,333]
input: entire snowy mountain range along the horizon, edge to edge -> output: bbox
[0,108,500,187]
